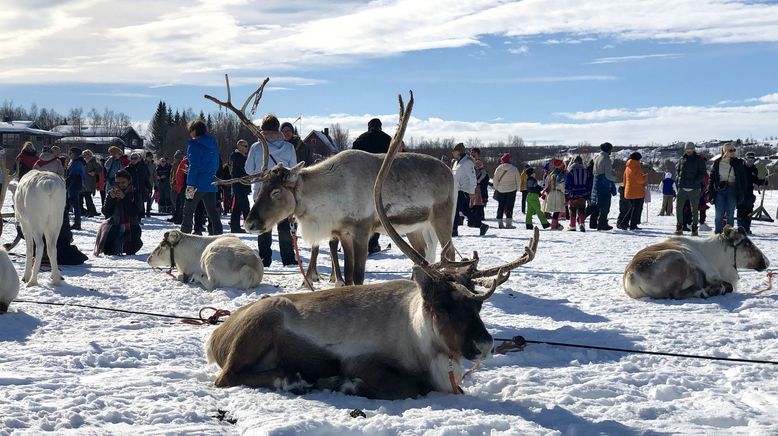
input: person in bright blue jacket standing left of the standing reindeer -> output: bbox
[181,119,223,235]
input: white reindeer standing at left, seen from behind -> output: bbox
[14,170,65,287]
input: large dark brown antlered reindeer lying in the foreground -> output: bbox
[206,94,539,399]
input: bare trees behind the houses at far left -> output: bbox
[0,100,131,134]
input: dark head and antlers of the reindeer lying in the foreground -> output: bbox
[373,93,540,360]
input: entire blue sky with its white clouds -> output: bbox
[0,0,778,145]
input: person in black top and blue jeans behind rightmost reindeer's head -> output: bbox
[708,143,748,235]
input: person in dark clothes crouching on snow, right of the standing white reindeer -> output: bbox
[94,170,143,256]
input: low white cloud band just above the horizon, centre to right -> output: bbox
[300,94,778,145]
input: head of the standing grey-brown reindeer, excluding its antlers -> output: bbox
[244,162,304,234]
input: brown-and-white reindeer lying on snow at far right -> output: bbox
[624,227,770,299]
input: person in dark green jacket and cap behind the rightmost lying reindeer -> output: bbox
[673,142,707,236]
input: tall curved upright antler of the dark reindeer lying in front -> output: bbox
[373,91,428,274]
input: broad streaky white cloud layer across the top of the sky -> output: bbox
[0,0,778,85]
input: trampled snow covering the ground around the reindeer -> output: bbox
[0,191,778,436]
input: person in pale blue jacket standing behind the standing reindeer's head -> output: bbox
[245,114,297,267]
